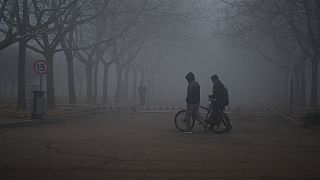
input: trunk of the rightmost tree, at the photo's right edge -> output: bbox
[310,57,319,108]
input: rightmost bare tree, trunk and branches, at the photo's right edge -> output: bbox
[273,0,320,107]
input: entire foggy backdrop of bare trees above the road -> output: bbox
[0,0,320,110]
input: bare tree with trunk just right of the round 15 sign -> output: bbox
[28,0,107,108]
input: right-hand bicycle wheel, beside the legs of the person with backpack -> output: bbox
[209,113,229,133]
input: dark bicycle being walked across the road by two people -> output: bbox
[174,98,232,133]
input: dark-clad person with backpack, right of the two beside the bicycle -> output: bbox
[209,74,232,129]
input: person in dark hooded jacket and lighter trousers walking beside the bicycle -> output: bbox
[185,72,207,133]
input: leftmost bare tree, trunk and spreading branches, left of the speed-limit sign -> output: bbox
[7,0,76,110]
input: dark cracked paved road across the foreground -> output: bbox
[0,114,320,180]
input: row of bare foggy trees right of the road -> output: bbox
[217,0,320,107]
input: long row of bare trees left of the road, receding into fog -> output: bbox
[0,0,199,110]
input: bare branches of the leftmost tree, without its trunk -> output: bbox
[0,0,63,50]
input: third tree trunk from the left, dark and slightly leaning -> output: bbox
[61,43,77,104]
